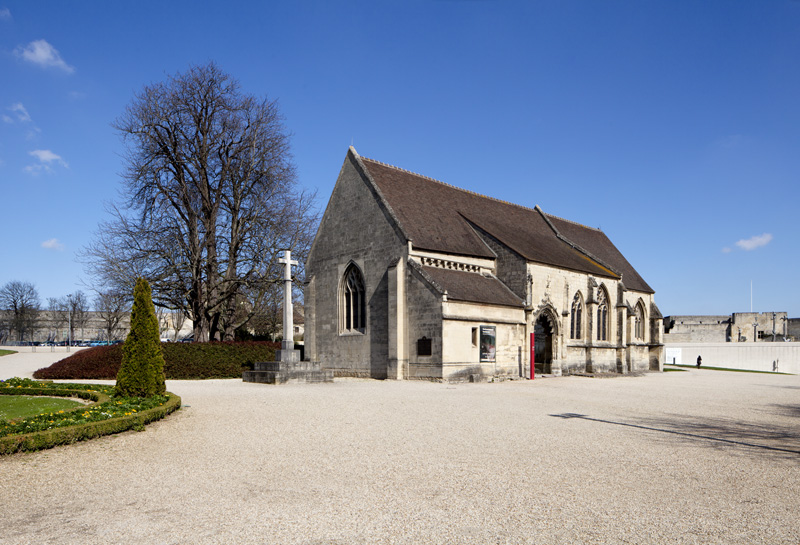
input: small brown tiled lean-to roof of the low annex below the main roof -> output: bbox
[419,266,523,308]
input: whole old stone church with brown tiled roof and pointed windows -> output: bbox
[305,147,663,380]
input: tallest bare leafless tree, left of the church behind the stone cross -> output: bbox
[84,63,317,340]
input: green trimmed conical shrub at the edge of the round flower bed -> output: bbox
[116,278,166,397]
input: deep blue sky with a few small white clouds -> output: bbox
[0,0,800,316]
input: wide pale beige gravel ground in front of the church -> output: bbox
[0,348,800,545]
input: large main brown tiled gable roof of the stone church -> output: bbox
[350,147,653,293]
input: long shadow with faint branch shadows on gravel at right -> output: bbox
[550,412,800,460]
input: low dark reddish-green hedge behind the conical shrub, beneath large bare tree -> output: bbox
[33,341,280,380]
